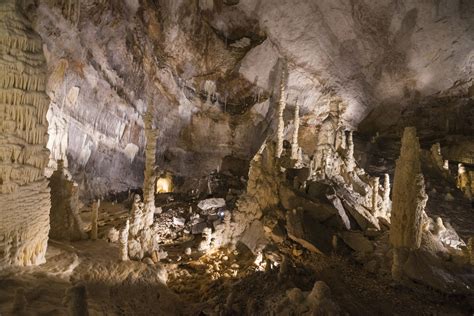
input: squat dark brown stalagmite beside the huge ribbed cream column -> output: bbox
[49,161,85,240]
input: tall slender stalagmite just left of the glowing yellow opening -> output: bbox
[143,111,158,227]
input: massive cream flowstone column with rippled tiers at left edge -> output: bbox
[0,1,51,267]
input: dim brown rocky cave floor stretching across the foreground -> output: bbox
[0,201,471,315]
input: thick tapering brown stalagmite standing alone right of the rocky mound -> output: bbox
[390,127,428,280]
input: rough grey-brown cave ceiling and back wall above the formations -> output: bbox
[24,0,474,198]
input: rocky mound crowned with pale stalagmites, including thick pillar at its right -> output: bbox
[221,73,472,292]
